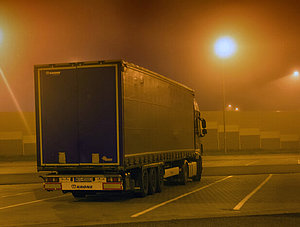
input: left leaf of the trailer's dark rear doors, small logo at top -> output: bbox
[38,67,80,164]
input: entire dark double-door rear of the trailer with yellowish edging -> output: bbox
[37,64,120,166]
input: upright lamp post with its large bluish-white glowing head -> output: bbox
[214,36,236,154]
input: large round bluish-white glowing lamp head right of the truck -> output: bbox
[214,36,236,58]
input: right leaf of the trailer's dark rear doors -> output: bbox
[77,66,119,164]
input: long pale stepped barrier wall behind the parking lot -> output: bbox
[0,111,300,156]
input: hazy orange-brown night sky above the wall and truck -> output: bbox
[0,0,300,112]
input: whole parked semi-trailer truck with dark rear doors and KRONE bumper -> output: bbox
[34,60,207,198]
